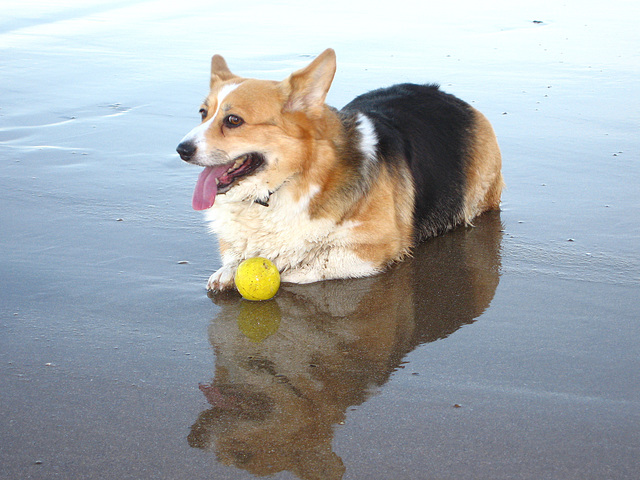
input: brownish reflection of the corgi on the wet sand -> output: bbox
[189,212,501,479]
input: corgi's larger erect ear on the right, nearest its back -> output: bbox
[283,48,336,114]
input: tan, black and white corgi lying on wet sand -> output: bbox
[177,49,503,292]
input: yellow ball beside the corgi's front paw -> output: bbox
[234,257,280,300]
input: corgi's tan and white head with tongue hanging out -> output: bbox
[177,49,336,210]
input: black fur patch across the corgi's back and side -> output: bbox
[340,83,474,241]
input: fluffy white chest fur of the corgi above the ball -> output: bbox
[206,183,376,283]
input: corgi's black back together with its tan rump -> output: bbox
[340,84,503,242]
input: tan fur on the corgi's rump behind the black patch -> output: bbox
[464,110,504,224]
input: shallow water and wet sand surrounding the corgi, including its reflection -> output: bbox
[0,0,640,479]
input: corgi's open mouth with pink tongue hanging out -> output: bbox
[192,152,264,210]
